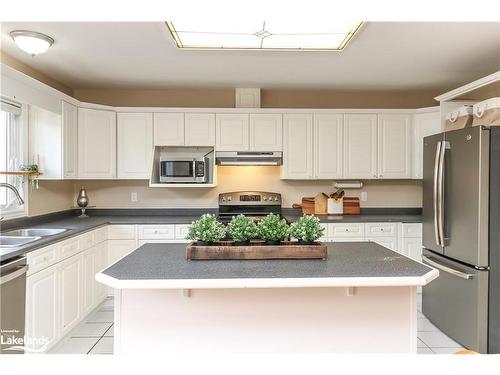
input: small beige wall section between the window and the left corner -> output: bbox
[28,180,74,216]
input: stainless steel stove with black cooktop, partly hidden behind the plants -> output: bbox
[218,191,281,223]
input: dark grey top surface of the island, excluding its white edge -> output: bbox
[101,242,434,288]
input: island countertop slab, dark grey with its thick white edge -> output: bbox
[96,242,439,289]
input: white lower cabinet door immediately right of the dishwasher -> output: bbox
[26,265,60,351]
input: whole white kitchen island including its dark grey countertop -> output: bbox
[96,242,438,354]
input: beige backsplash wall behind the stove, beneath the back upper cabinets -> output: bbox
[73,167,422,208]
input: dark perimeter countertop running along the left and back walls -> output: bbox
[0,208,422,261]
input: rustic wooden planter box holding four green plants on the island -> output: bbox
[186,242,327,260]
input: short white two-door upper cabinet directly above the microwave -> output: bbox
[153,113,215,146]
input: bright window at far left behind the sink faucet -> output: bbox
[0,97,27,218]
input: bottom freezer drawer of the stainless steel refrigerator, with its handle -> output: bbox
[422,250,489,353]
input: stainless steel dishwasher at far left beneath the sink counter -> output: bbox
[0,256,28,354]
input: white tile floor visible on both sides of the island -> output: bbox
[50,295,463,354]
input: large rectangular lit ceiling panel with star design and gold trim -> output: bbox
[166,19,363,51]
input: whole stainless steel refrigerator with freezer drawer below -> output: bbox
[422,126,500,353]
